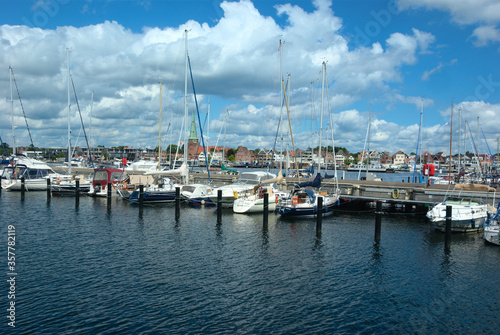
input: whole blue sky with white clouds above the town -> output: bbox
[0,0,500,158]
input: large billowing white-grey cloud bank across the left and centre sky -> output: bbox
[0,0,496,156]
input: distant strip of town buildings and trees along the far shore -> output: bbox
[6,141,499,172]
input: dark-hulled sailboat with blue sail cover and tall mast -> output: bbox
[276,62,340,217]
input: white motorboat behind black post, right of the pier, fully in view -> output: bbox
[426,196,488,233]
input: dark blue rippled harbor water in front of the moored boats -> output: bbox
[0,191,500,334]
